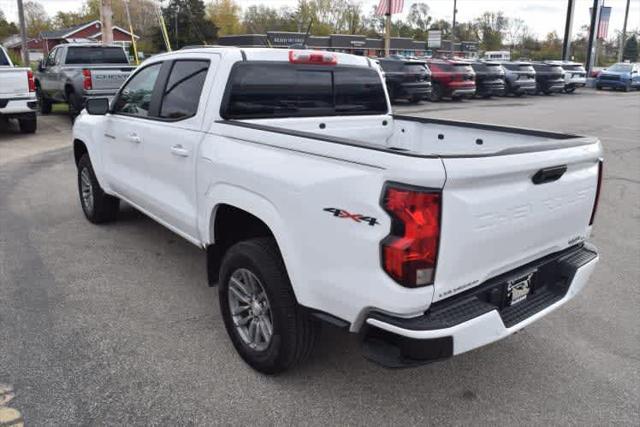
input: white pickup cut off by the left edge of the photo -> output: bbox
[0,46,38,133]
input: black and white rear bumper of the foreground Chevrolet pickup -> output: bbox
[361,246,598,367]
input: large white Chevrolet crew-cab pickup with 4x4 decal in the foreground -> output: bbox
[73,48,602,373]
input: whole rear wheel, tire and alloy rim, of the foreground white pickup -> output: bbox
[219,238,318,374]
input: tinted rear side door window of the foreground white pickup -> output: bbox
[160,60,209,120]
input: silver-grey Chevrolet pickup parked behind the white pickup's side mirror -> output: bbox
[35,43,135,120]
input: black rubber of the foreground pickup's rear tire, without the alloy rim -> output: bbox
[219,238,319,375]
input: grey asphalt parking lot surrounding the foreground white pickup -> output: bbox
[0,90,640,425]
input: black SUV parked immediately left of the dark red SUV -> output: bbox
[378,56,431,103]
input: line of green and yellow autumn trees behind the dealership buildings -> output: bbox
[0,0,638,60]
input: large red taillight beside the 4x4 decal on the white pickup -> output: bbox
[381,184,442,288]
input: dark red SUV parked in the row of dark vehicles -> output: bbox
[427,59,476,102]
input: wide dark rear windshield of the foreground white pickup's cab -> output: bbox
[221,61,388,119]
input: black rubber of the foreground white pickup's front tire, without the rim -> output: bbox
[78,154,120,224]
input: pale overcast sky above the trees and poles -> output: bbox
[0,0,640,38]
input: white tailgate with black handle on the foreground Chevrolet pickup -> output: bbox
[434,143,601,301]
